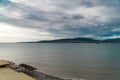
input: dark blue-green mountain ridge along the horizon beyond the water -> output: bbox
[35,38,120,43]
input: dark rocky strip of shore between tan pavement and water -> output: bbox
[1,60,72,80]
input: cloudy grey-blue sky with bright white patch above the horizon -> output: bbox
[0,0,120,42]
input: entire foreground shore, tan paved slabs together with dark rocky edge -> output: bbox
[0,60,71,80]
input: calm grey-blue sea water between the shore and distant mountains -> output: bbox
[0,43,120,80]
